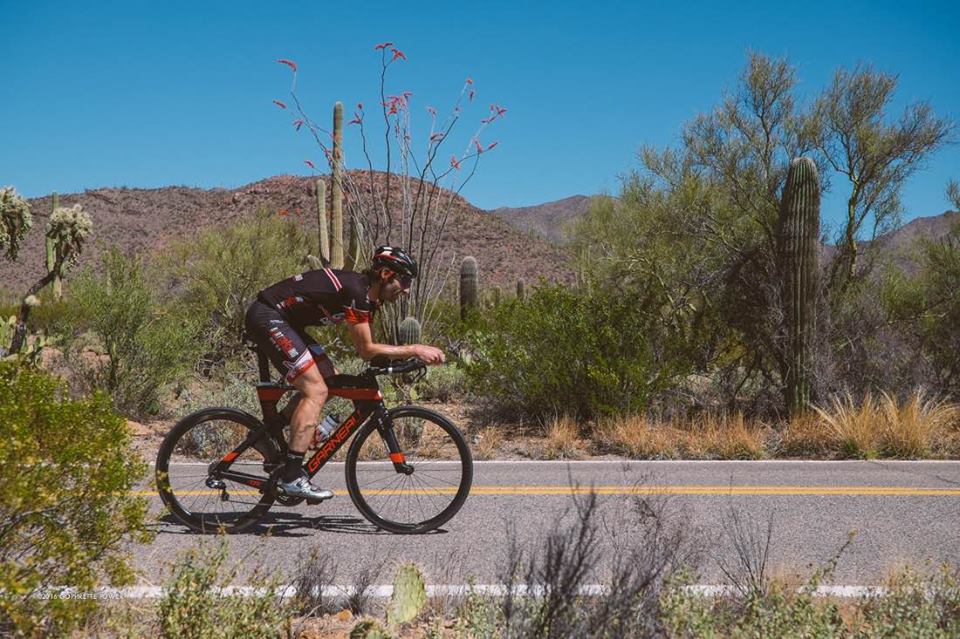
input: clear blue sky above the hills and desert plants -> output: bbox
[0,0,960,230]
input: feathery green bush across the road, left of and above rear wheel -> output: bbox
[71,248,199,416]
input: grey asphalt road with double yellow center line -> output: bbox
[135,461,960,585]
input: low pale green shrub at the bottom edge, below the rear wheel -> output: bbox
[158,541,287,639]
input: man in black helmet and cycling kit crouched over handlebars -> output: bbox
[245,246,444,501]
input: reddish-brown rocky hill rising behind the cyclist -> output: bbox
[0,174,574,298]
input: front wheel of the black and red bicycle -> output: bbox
[346,406,473,533]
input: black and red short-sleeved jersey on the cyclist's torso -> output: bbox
[257,268,380,326]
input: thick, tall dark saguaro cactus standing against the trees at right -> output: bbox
[777,157,820,416]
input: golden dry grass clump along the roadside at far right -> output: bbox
[783,391,960,459]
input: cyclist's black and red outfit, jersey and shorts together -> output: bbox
[245,268,380,382]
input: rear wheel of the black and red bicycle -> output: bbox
[156,408,282,533]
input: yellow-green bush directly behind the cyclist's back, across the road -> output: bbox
[155,210,311,362]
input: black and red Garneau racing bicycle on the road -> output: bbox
[156,351,473,533]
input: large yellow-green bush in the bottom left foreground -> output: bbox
[0,362,146,636]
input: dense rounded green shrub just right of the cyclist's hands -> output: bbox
[467,285,689,419]
